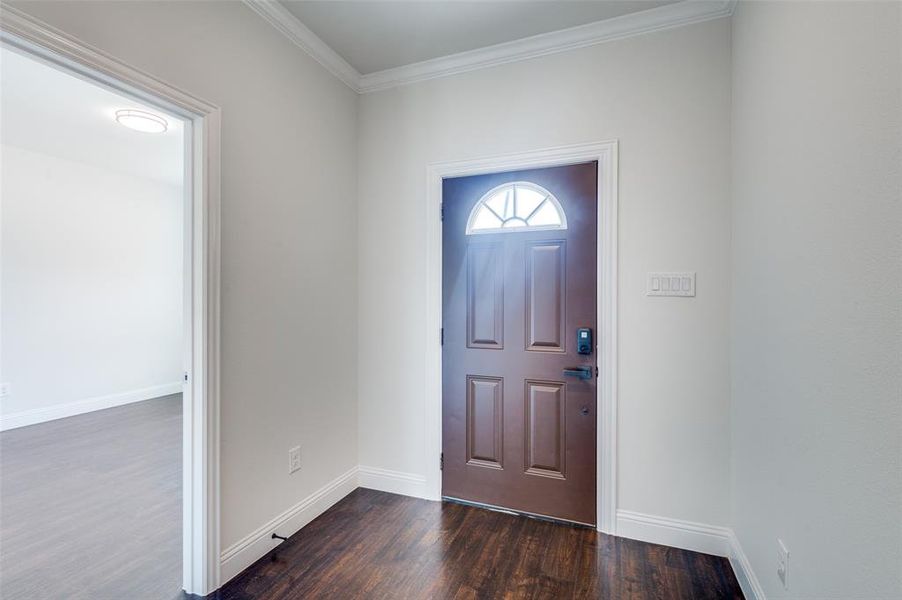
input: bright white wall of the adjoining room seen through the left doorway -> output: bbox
[0,145,184,427]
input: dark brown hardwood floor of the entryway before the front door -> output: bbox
[211,489,742,600]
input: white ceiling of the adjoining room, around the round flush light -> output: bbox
[0,48,184,185]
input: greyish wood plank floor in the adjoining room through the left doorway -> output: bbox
[0,394,182,600]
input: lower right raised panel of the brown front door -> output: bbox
[526,381,566,479]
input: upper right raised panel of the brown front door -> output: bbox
[526,241,566,352]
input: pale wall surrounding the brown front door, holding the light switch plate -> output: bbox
[358,19,730,525]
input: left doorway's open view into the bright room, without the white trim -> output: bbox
[0,42,191,598]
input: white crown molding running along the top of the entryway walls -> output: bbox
[243,0,738,94]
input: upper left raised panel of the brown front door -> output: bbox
[467,244,504,350]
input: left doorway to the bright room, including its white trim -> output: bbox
[0,7,219,597]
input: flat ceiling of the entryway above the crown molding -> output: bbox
[281,0,677,75]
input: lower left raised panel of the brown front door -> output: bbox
[467,375,504,469]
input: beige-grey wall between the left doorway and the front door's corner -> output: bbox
[7,1,357,564]
